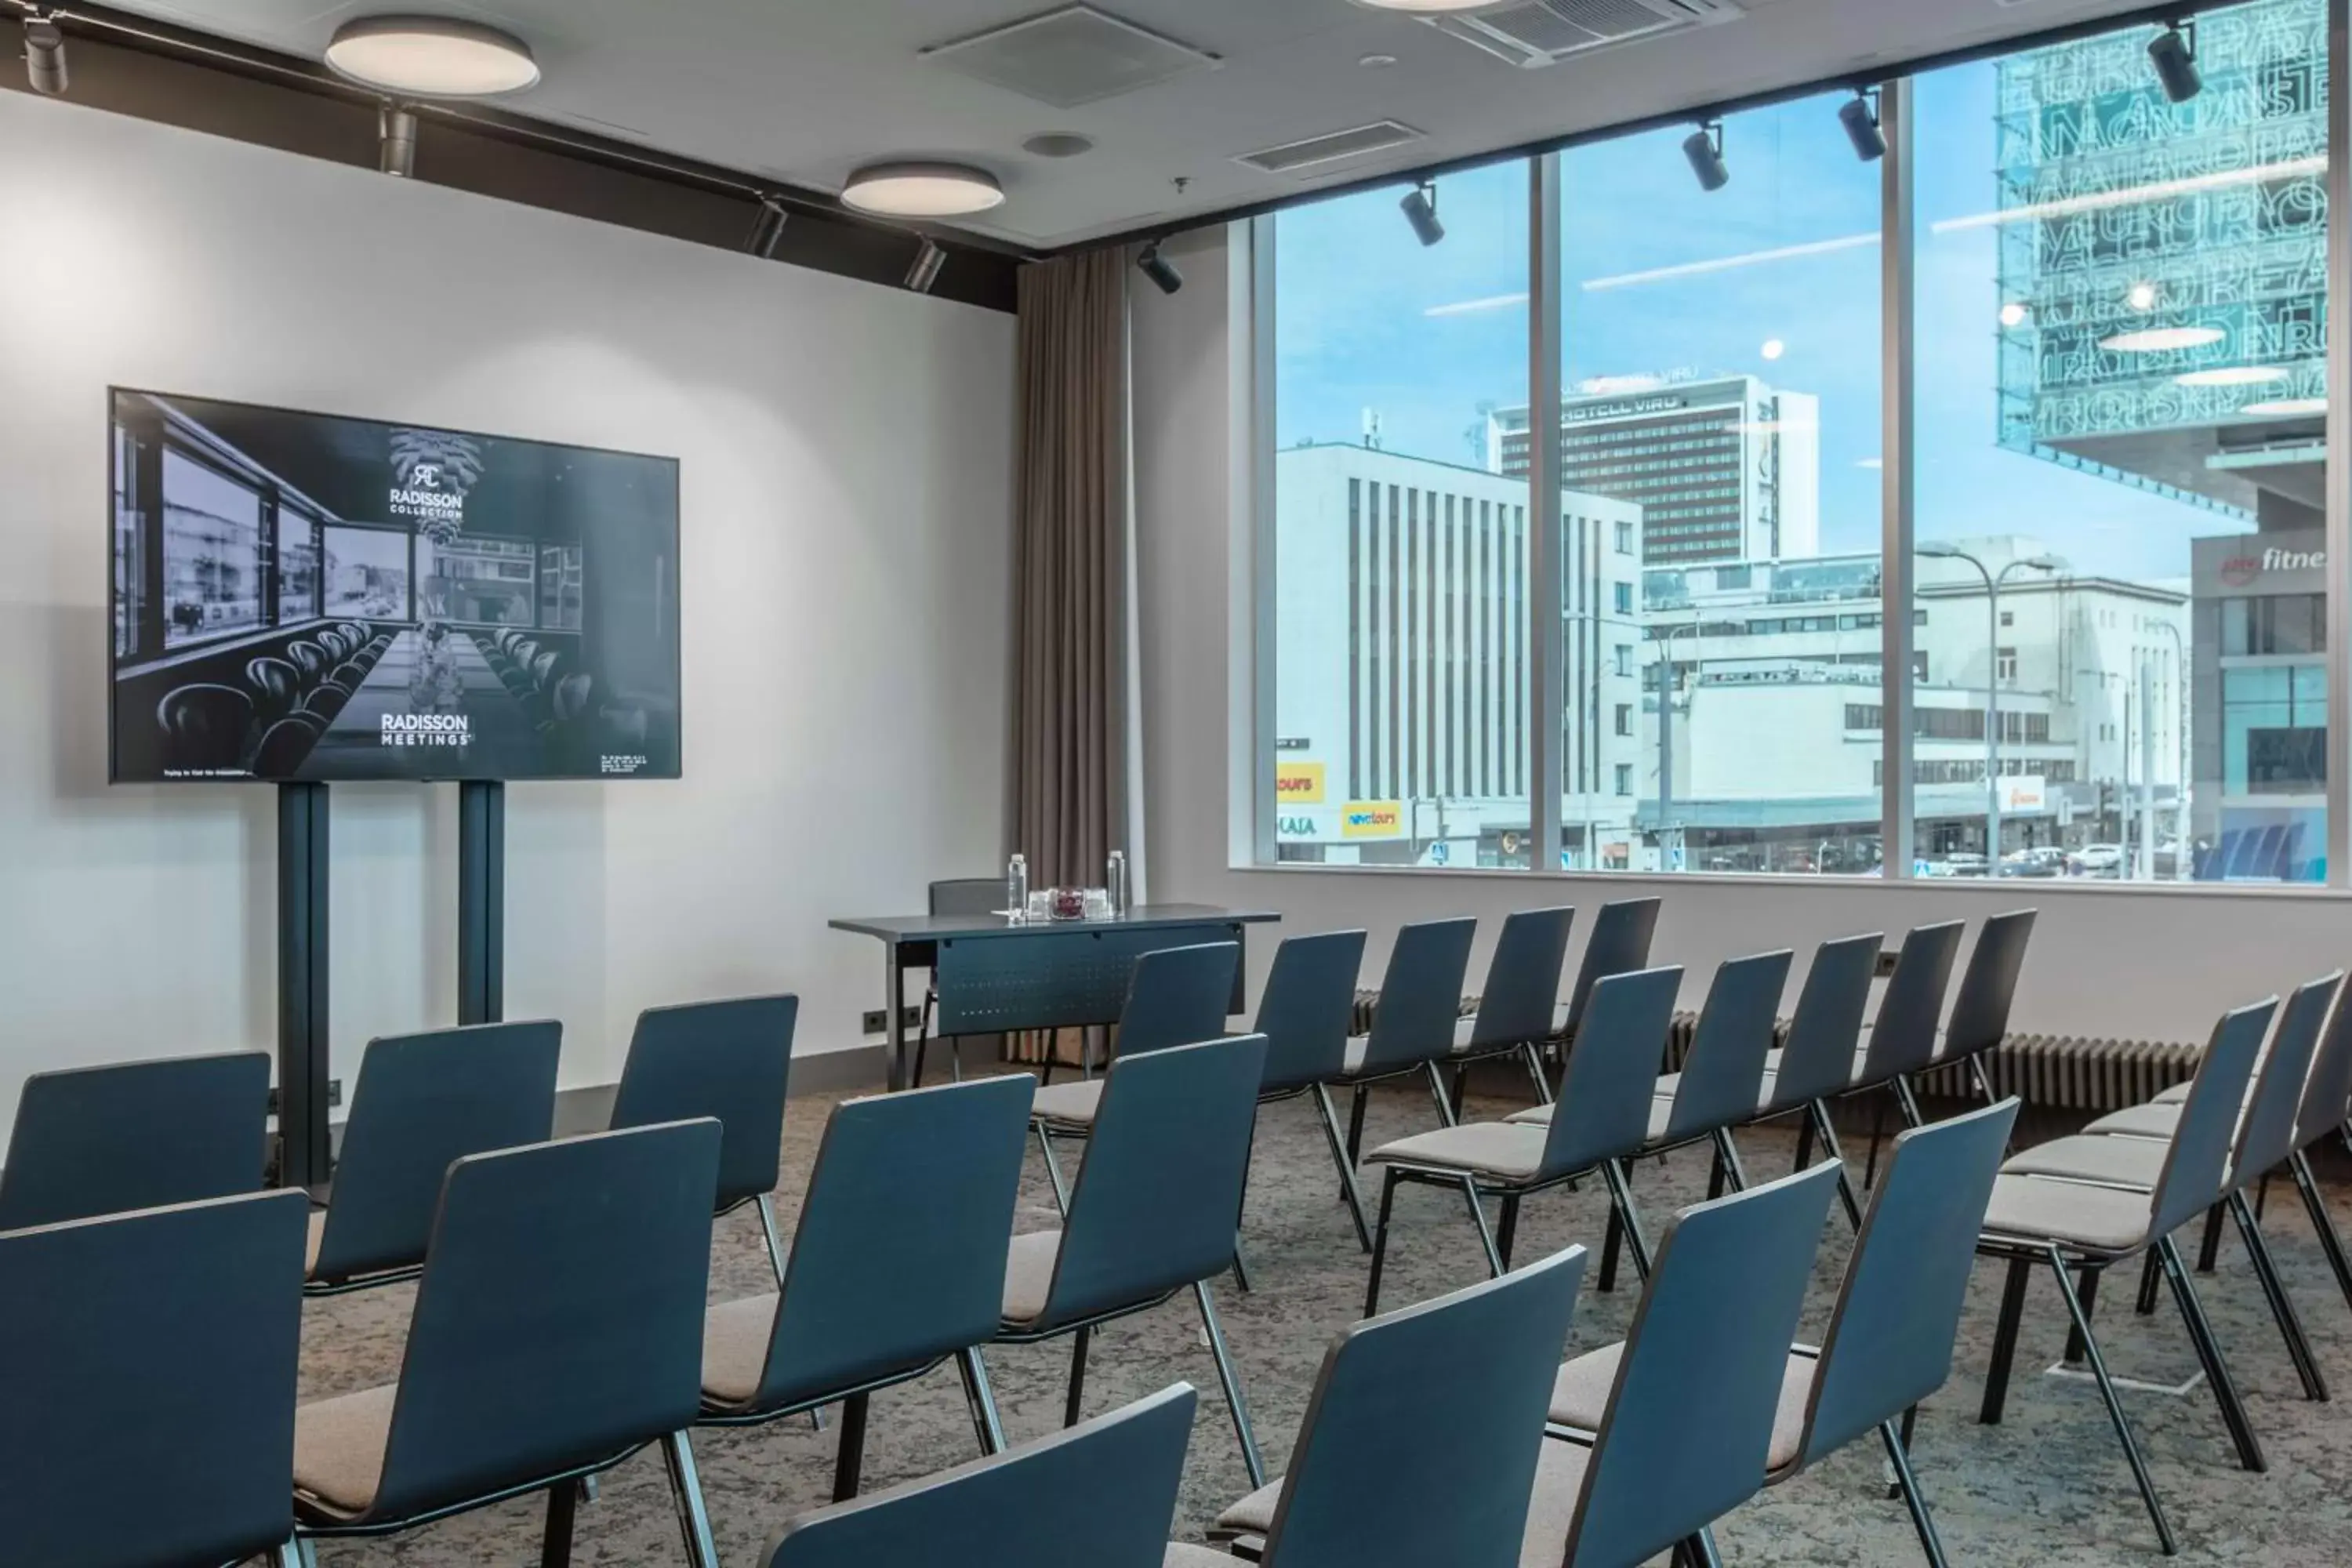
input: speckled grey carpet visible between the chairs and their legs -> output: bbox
[303,1093,2352,1568]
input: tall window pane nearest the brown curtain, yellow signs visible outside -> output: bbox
[1261,162,1531,865]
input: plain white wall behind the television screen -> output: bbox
[0,94,1014,1126]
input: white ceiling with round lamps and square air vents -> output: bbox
[120,0,2173,249]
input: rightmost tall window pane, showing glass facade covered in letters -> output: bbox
[1912,0,2328,881]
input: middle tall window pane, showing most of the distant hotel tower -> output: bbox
[1559,99,1882,872]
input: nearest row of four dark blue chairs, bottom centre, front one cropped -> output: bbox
[781,1091,2016,1568]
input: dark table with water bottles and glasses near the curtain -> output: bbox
[828,902,1282,1091]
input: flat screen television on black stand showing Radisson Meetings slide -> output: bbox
[108,388,680,783]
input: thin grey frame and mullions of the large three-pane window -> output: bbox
[1228,0,2352,898]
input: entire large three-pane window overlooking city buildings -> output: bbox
[1251,0,2352,884]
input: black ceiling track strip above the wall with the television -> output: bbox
[0,0,1035,310]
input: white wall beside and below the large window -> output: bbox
[1136,220,2352,1039]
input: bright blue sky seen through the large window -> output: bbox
[1275,64,2246,579]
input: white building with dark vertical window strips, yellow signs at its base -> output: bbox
[1275,445,1642,865]
